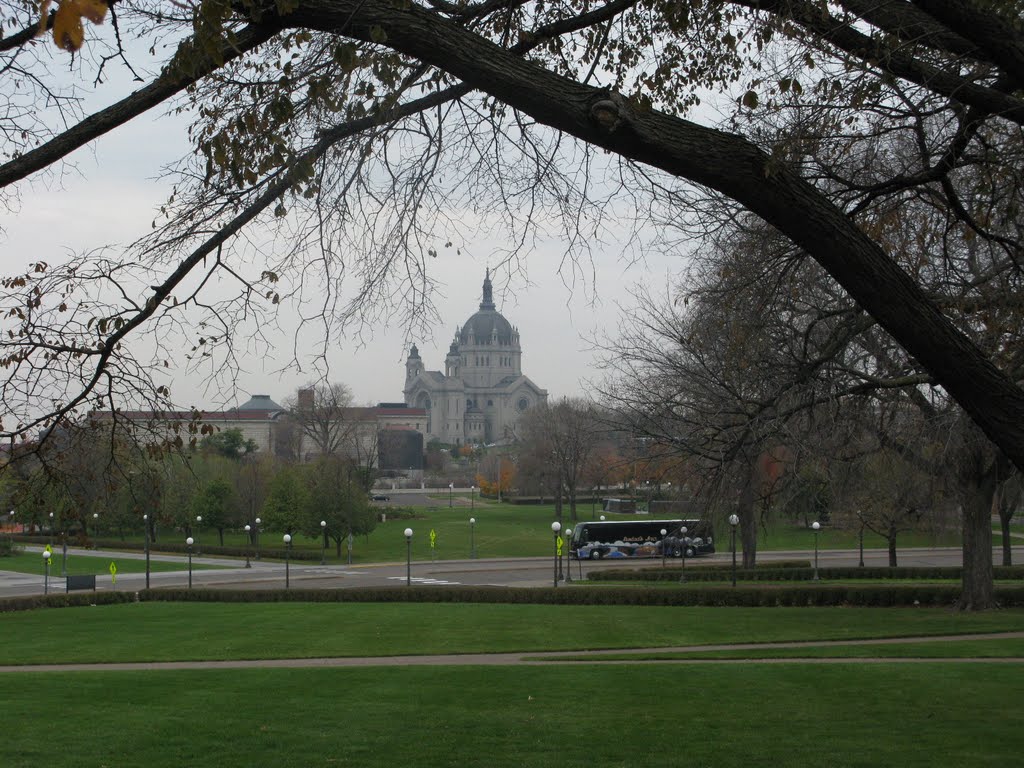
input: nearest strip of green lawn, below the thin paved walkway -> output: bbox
[3,664,1024,768]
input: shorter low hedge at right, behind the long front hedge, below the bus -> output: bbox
[587,563,1024,582]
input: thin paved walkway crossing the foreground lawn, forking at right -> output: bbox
[0,632,1024,673]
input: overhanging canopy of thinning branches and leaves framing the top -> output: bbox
[6,0,1024,481]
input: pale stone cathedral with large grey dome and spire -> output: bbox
[406,269,548,445]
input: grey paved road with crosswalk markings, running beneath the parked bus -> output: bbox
[0,546,1024,597]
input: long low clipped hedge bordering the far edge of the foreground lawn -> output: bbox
[139,584,1024,607]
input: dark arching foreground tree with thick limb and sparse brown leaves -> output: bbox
[0,0,1024,481]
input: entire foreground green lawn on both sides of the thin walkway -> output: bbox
[0,602,1024,768]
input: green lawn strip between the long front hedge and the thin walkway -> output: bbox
[0,602,1024,664]
